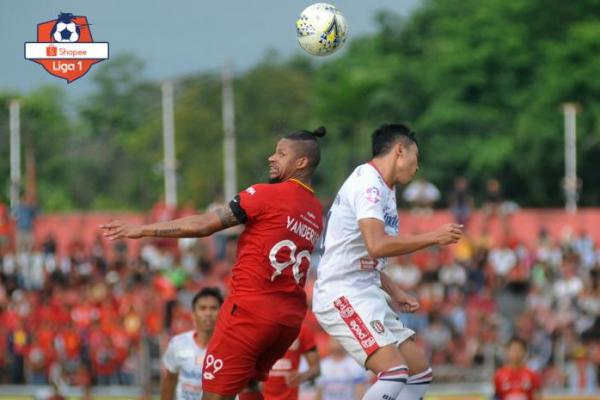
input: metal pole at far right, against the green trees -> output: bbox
[563,103,577,214]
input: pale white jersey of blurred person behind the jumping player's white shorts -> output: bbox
[317,356,368,400]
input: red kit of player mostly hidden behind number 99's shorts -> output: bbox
[263,325,317,400]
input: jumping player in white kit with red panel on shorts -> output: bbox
[313,124,462,400]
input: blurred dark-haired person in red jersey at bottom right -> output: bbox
[494,338,541,400]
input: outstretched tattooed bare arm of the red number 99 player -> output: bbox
[100,204,241,240]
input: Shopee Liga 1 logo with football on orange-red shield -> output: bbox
[25,12,108,83]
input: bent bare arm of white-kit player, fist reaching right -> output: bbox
[358,218,462,259]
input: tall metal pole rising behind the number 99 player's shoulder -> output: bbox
[223,62,237,201]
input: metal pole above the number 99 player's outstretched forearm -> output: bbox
[162,81,177,207]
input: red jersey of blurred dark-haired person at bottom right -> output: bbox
[494,366,541,400]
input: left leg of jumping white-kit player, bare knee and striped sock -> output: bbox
[363,344,408,400]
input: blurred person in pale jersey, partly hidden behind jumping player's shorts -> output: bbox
[317,338,369,400]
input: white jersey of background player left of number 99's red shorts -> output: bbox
[162,331,206,400]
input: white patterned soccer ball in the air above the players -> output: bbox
[296,3,348,56]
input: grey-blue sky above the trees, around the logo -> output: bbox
[0,0,421,97]
